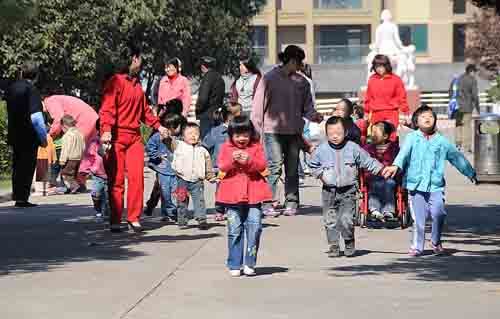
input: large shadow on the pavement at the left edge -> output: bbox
[0,204,220,276]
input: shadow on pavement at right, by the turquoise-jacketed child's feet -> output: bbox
[330,205,500,282]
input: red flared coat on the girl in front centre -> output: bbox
[216,141,273,205]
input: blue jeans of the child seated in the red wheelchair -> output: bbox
[368,176,397,214]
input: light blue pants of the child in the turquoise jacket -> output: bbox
[410,191,446,252]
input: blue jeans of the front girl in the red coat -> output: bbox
[227,207,262,270]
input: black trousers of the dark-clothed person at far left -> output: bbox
[12,143,38,202]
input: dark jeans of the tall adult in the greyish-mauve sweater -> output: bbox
[264,133,302,208]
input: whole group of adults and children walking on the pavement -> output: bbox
[3,45,475,277]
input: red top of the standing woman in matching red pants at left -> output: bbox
[99,74,160,133]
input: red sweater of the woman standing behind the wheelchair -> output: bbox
[365,73,410,114]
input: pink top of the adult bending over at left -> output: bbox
[43,95,99,144]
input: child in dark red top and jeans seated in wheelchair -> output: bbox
[364,121,399,221]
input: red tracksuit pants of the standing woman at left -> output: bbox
[105,132,144,224]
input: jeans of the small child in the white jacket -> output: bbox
[177,178,207,225]
